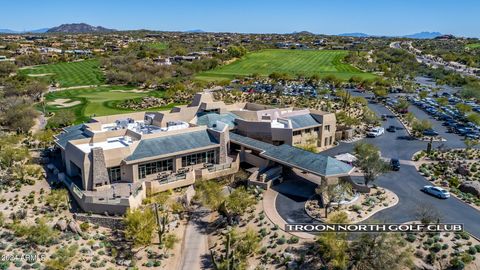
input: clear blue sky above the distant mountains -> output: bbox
[0,0,480,37]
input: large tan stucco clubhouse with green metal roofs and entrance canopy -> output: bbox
[56,91,352,214]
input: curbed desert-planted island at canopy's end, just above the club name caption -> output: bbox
[305,187,399,223]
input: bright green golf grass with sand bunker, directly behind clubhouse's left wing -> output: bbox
[43,86,176,122]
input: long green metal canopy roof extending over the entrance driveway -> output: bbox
[230,133,352,177]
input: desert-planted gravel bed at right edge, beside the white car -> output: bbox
[412,149,480,210]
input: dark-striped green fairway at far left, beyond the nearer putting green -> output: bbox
[20,59,104,87]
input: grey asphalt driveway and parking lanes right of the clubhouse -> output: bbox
[274,92,480,237]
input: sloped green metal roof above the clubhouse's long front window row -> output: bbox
[125,130,219,161]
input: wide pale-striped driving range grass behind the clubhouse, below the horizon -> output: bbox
[196,50,375,81]
